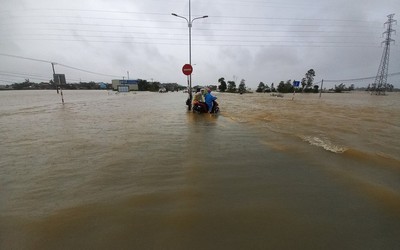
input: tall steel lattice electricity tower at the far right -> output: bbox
[372,14,397,95]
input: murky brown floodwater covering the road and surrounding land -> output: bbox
[0,91,400,250]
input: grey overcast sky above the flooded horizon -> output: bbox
[0,0,400,89]
